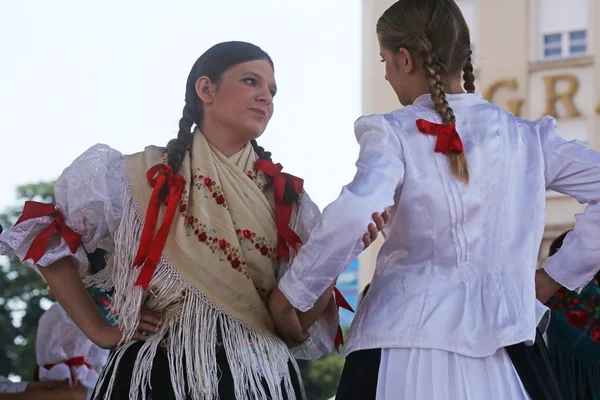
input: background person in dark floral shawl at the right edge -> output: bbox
[546,231,600,400]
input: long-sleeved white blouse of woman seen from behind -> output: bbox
[279,94,600,357]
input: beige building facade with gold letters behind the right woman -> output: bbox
[359,0,600,287]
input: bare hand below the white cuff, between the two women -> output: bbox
[269,288,310,348]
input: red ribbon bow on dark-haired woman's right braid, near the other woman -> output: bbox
[255,159,304,259]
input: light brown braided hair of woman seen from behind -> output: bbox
[377,0,475,183]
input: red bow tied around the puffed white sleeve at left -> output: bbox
[15,201,81,263]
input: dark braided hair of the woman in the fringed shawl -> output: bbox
[162,42,298,202]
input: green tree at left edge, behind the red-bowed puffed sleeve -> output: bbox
[0,182,55,379]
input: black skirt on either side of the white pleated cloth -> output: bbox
[336,331,562,400]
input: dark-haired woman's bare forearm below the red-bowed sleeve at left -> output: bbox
[39,257,108,343]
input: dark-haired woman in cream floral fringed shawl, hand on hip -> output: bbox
[0,42,384,400]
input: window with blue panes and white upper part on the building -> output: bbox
[537,0,595,60]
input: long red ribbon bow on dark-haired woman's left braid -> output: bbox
[132,164,186,290]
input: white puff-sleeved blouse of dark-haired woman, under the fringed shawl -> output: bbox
[0,144,338,359]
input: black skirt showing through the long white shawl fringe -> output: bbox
[92,342,302,400]
